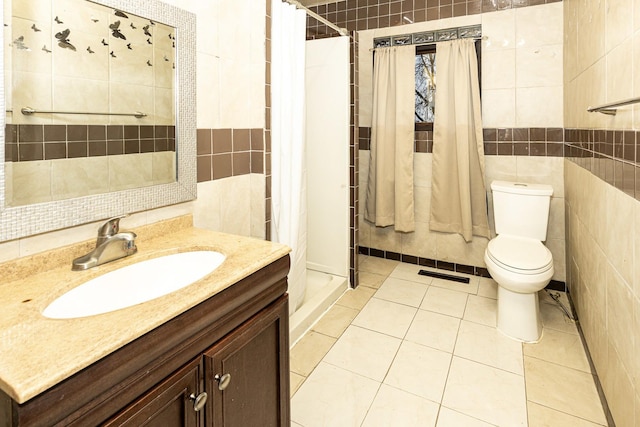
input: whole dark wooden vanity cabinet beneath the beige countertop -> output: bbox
[0,255,290,427]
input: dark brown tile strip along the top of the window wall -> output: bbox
[307,0,562,38]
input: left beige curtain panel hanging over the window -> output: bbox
[364,46,415,232]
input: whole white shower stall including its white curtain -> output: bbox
[271,0,350,344]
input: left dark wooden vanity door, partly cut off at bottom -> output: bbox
[104,358,204,427]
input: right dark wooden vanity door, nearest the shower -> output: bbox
[204,295,289,427]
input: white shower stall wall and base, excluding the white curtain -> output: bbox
[289,36,350,343]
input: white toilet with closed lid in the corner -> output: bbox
[484,181,553,342]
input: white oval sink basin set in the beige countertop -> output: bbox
[42,251,225,319]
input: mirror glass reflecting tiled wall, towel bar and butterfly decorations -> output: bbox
[4,0,176,206]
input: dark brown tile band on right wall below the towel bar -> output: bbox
[565,129,640,200]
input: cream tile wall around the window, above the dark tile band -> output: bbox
[360,2,565,128]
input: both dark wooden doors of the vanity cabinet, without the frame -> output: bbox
[105,297,289,427]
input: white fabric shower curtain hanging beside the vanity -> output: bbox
[271,0,307,314]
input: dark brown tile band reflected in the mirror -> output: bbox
[5,124,176,162]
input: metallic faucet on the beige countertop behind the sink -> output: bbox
[71,216,138,270]
